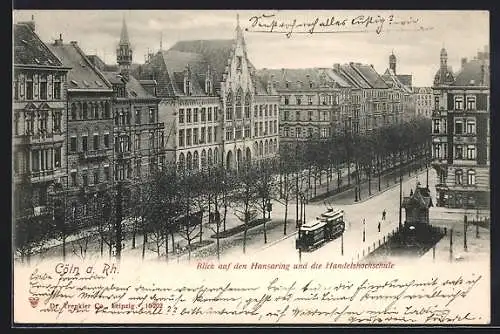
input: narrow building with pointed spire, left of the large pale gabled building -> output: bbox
[97,20,165,187]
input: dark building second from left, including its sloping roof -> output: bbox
[47,35,114,225]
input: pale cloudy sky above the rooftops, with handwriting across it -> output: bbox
[14,10,490,86]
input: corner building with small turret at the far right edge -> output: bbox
[432,48,490,208]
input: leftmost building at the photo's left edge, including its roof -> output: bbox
[12,21,69,218]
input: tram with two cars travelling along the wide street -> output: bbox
[295,209,345,251]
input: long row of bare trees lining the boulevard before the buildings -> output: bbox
[15,119,430,260]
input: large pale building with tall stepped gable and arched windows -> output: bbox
[134,16,279,169]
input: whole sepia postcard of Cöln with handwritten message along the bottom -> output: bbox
[11,9,491,326]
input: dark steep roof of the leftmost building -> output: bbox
[13,24,63,67]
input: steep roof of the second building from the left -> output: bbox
[47,41,111,91]
